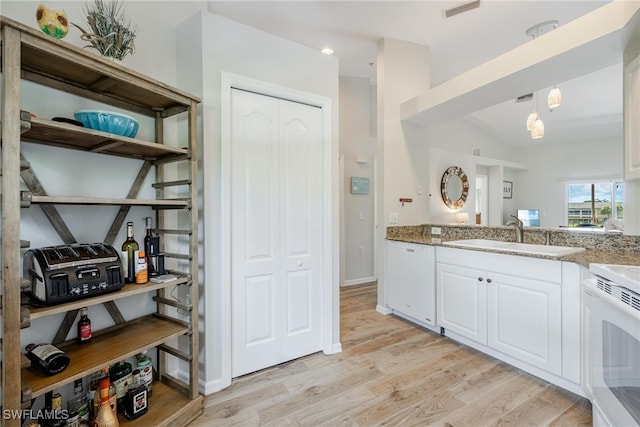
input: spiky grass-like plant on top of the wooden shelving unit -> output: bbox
[72,0,138,61]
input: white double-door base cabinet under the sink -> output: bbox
[436,248,562,375]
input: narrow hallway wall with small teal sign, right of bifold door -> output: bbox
[340,77,376,285]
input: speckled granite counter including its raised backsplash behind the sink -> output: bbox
[387,224,640,267]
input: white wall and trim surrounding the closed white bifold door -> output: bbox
[178,13,339,393]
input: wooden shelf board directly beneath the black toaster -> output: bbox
[27,277,188,320]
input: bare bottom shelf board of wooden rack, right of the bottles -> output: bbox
[118,381,204,427]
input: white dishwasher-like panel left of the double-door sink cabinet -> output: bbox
[386,241,436,326]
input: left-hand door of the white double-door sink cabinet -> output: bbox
[437,263,487,344]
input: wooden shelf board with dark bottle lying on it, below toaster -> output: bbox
[22,316,188,397]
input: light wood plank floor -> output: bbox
[191,285,592,427]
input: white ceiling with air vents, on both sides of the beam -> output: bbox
[208,0,622,146]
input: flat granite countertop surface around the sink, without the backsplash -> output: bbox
[387,235,640,267]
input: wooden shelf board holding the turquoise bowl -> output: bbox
[21,117,188,160]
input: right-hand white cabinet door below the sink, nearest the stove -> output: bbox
[486,272,562,375]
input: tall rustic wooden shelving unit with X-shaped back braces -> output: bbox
[0,16,203,427]
